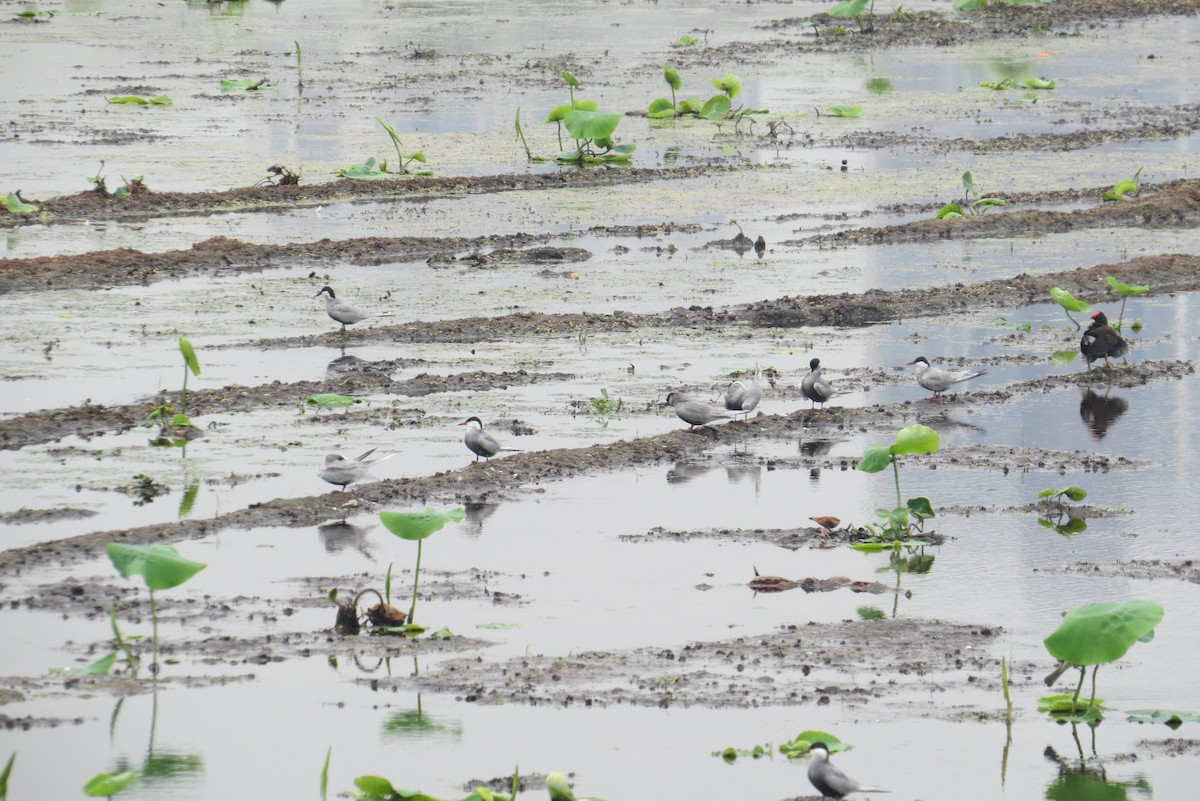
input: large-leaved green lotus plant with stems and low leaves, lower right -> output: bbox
[1039,598,1164,713]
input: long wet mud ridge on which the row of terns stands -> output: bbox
[0,361,1195,573]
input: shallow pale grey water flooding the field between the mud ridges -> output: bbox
[0,0,1200,800]
